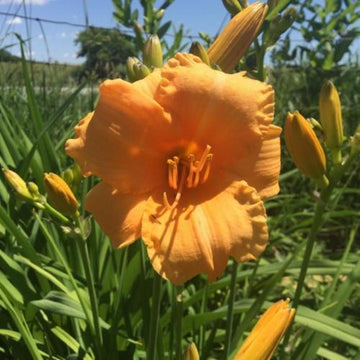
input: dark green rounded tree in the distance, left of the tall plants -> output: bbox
[75,27,135,79]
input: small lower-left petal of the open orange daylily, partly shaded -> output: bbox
[85,182,148,248]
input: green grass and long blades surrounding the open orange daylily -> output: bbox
[0,55,360,360]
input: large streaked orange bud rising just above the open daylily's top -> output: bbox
[208,2,268,73]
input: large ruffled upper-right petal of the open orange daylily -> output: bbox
[155,54,280,196]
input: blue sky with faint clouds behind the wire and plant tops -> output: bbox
[0,0,229,63]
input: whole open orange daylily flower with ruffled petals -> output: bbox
[66,54,281,284]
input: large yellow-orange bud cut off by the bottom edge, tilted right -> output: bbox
[234,300,295,360]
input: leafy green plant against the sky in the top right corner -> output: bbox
[273,0,360,70]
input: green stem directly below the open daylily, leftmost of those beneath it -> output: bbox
[146,273,162,360]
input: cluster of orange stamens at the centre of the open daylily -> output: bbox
[163,145,213,210]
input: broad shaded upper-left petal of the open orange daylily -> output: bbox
[66,74,172,193]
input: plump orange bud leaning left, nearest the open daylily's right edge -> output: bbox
[285,111,328,186]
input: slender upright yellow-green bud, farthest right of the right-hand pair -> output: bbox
[319,81,344,164]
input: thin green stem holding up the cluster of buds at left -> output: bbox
[76,216,103,359]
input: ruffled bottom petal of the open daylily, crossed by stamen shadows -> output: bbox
[141,181,268,284]
